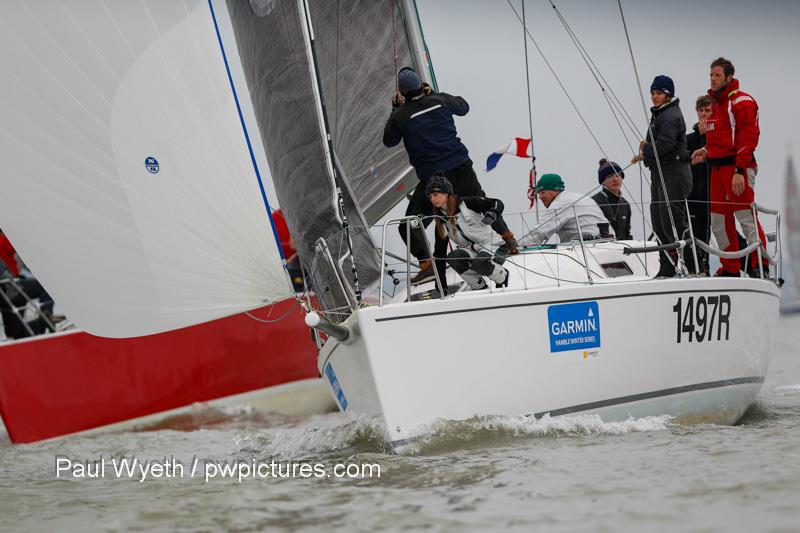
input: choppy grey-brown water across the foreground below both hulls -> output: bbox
[0,317,800,532]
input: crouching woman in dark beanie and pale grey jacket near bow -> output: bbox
[425,176,508,290]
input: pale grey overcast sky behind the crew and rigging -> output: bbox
[412,0,800,236]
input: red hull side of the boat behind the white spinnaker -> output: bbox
[0,299,319,443]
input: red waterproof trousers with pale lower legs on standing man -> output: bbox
[711,165,768,274]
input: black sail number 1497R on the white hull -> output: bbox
[672,294,731,342]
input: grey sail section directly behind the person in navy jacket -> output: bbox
[309,0,417,223]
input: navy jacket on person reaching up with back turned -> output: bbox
[383,93,469,182]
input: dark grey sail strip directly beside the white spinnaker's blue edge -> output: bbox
[227,0,380,310]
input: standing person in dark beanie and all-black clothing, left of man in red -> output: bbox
[631,75,694,278]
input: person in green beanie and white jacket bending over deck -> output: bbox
[522,174,608,246]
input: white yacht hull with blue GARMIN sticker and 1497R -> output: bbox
[319,245,779,445]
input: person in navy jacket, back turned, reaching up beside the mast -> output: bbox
[383,67,518,285]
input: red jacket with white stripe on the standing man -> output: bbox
[706,78,761,169]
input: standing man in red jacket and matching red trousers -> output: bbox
[692,57,769,277]
